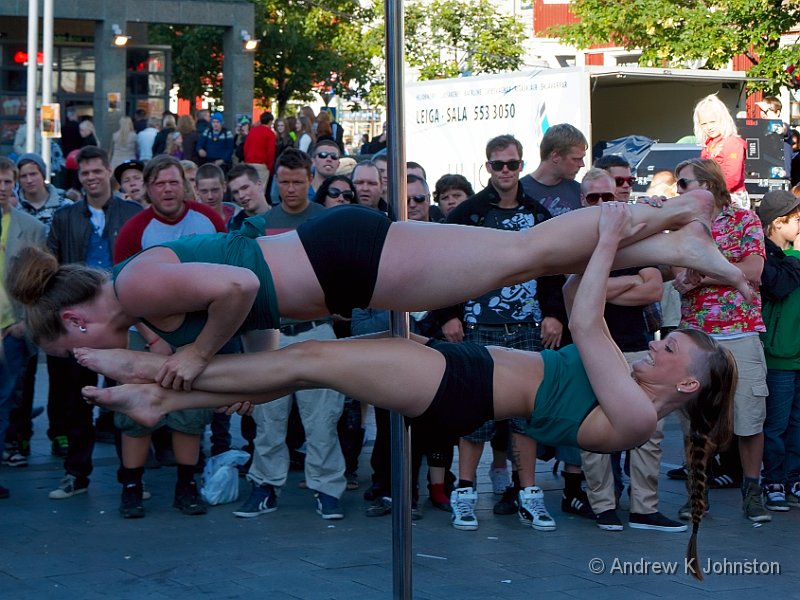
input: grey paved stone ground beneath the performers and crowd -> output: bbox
[0,358,800,600]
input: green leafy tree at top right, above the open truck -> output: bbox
[550,0,800,91]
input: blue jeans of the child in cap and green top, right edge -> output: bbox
[761,369,800,484]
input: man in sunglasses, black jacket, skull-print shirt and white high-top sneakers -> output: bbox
[437,135,566,531]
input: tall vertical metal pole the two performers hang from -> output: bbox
[384,0,412,600]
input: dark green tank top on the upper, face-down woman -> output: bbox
[112,229,280,347]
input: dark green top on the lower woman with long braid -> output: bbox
[525,344,598,448]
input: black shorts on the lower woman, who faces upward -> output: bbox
[411,340,494,437]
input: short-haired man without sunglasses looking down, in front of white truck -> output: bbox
[520,123,589,217]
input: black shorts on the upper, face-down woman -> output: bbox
[297,205,391,315]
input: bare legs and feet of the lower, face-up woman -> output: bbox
[82,339,454,423]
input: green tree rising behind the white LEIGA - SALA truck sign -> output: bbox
[405,0,525,79]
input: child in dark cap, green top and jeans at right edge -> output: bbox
[756,190,800,512]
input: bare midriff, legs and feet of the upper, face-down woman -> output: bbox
[259,190,750,319]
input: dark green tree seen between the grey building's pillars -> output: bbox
[148,25,223,103]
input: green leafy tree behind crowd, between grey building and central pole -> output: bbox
[254,0,376,115]
